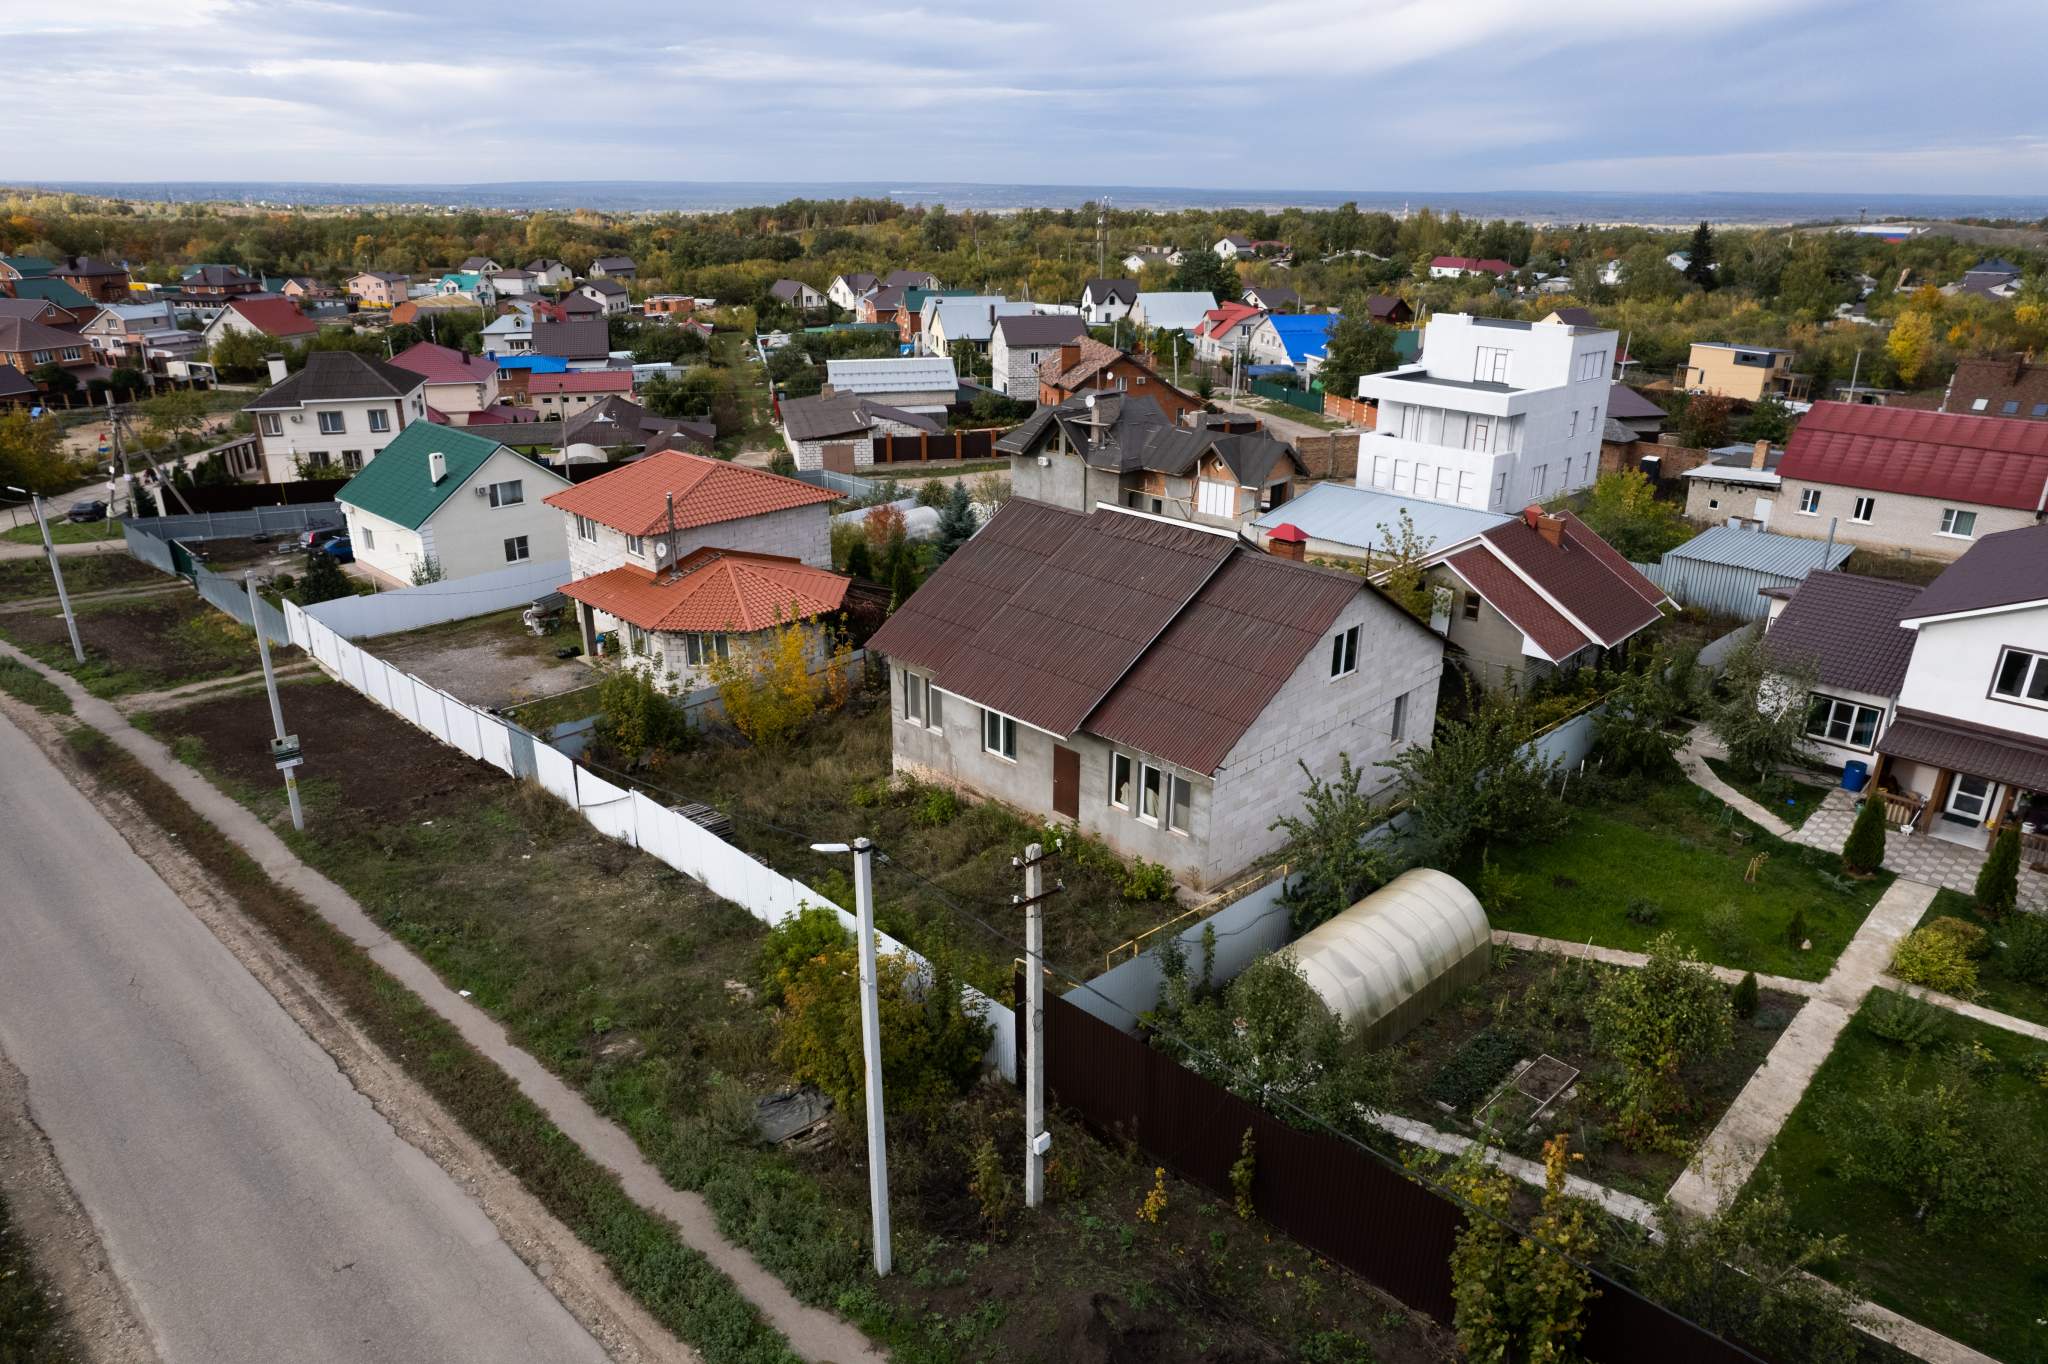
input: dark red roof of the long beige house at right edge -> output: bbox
[1778,403,2048,512]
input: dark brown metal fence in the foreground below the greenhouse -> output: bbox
[1040,975,1759,1364]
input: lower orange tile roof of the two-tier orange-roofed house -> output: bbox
[561,549,852,635]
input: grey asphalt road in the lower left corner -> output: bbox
[0,719,606,1364]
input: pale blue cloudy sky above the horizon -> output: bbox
[16,0,2048,195]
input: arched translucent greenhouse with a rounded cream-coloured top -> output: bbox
[1290,866,1493,1047]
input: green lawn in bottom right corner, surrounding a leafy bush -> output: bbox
[1759,991,2048,1364]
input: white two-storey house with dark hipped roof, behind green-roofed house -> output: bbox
[246,350,426,483]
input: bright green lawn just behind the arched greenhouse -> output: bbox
[1460,780,1890,981]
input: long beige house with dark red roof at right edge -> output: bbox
[1774,403,2048,559]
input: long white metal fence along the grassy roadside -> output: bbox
[284,592,1016,1081]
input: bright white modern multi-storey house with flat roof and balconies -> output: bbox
[1358,313,1618,512]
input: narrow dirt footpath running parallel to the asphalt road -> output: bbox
[0,645,889,1364]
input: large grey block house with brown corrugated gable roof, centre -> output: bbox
[868,498,1442,889]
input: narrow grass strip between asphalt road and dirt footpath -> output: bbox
[70,727,797,1364]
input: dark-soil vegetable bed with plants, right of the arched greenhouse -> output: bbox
[1393,946,1804,1200]
